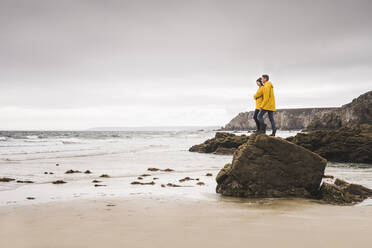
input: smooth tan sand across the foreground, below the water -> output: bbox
[0,197,372,248]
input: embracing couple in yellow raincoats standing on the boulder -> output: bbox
[253,75,276,136]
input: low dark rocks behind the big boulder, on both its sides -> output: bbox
[189,124,372,163]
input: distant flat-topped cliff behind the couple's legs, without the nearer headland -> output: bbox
[221,108,335,131]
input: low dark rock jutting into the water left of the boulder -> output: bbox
[189,132,249,155]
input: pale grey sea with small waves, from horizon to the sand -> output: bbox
[0,127,372,205]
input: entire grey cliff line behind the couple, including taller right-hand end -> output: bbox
[221,91,372,130]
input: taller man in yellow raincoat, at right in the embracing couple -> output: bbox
[257,75,276,136]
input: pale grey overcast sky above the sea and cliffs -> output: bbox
[0,0,372,129]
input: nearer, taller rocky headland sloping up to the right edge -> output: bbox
[306,91,372,130]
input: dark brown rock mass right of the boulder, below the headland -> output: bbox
[286,124,372,163]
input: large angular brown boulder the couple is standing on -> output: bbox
[216,134,327,198]
